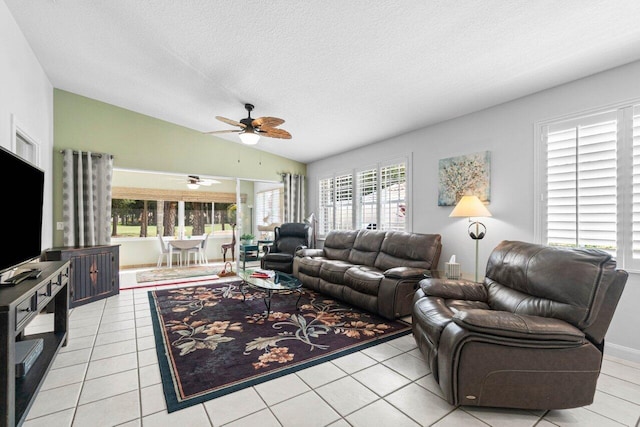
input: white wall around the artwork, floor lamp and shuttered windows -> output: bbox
[307,62,640,361]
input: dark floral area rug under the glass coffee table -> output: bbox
[148,281,411,412]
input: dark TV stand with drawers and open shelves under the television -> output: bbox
[0,261,70,427]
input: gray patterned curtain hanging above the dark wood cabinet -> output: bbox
[62,149,113,246]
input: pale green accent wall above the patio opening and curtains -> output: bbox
[53,89,307,246]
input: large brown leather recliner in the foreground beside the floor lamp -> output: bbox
[412,241,628,409]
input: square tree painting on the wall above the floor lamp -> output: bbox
[438,151,491,206]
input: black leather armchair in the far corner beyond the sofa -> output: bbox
[260,222,311,273]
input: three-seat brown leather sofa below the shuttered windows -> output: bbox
[293,229,442,319]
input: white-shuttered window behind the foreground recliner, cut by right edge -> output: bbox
[539,105,640,270]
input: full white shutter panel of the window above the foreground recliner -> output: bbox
[544,111,617,256]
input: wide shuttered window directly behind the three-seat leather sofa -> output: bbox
[318,160,407,236]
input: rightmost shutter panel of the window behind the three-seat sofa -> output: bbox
[380,162,407,231]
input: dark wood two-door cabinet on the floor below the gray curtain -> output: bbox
[43,245,120,307]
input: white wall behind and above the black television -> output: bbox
[0,1,53,249]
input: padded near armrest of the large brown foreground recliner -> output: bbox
[453,309,585,344]
